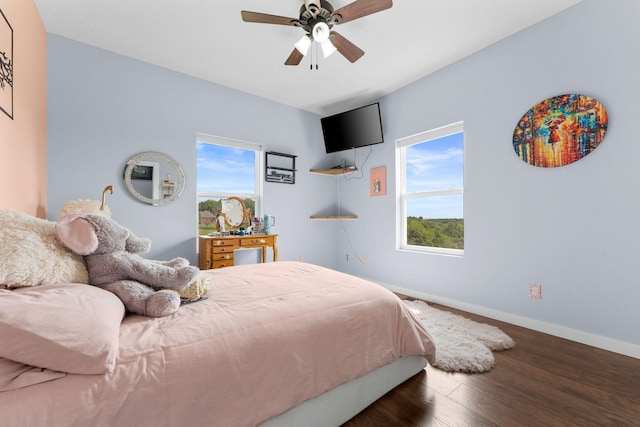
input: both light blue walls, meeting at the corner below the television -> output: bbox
[48,0,640,357]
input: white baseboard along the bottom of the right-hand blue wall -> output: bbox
[380,279,640,359]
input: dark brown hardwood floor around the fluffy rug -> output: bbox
[344,306,640,427]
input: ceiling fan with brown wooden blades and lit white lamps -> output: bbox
[241,0,393,65]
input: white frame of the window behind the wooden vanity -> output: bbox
[196,133,264,231]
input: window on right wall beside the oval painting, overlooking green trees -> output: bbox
[396,122,464,255]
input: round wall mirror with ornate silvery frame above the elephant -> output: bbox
[124,151,184,206]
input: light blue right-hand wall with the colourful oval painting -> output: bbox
[338,0,640,357]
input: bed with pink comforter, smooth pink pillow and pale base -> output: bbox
[0,252,435,427]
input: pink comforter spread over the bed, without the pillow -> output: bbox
[0,262,435,427]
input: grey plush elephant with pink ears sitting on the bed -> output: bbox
[56,214,200,317]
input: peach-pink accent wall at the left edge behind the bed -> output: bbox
[0,0,47,218]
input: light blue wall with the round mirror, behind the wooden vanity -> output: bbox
[47,34,336,267]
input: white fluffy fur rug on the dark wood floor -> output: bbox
[403,300,515,372]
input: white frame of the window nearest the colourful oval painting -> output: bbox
[396,121,464,256]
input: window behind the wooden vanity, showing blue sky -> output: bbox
[196,134,262,235]
